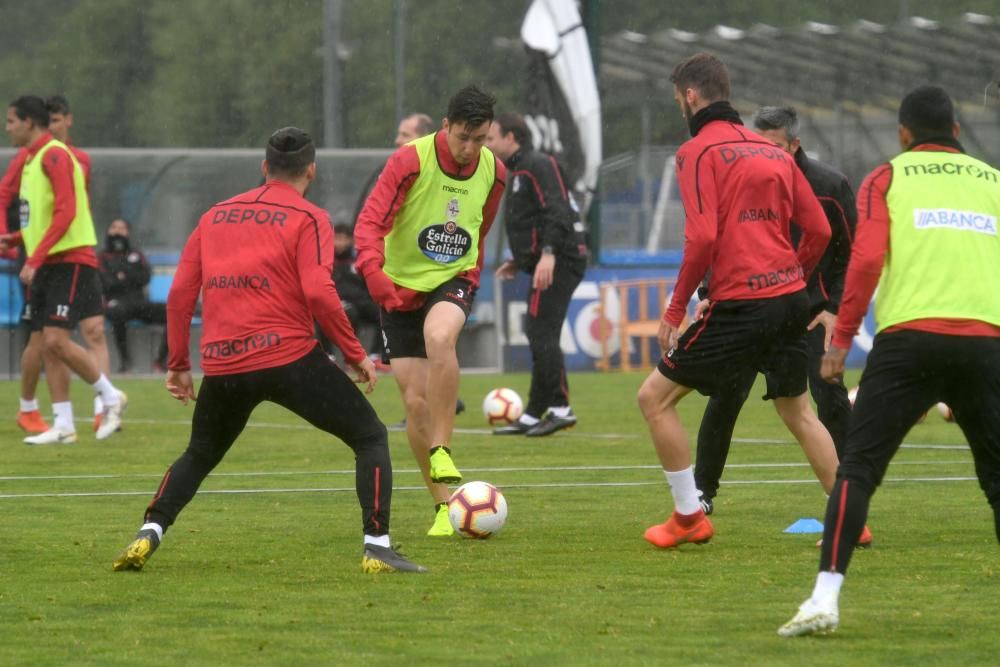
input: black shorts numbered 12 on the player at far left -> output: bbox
[23,262,104,331]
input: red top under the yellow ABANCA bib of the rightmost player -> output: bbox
[832,144,1000,350]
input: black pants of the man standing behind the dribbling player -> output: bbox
[524,257,586,418]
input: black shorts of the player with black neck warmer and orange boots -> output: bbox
[657,290,809,398]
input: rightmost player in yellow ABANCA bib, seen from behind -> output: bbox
[778,86,1000,637]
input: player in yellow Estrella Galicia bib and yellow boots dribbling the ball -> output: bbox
[354,86,506,536]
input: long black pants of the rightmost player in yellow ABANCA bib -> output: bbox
[820,331,1000,573]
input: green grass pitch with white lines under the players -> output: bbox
[0,374,998,666]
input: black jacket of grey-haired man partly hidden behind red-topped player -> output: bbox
[792,148,858,315]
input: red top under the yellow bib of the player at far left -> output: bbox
[0,132,97,269]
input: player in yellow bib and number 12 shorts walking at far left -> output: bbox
[0,96,127,445]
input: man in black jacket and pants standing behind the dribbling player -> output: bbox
[486,113,587,437]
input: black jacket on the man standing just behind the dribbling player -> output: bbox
[503,147,587,273]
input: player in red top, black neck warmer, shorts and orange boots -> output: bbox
[638,53,837,548]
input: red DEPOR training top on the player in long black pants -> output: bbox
[167,180,365,375]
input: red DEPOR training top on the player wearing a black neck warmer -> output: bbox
[663,120,831,327]
